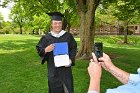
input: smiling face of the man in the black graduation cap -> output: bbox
[51,20,62,33]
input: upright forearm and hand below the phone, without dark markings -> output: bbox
[88,54,102,93]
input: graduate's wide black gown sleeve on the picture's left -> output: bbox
[36,36,48,64]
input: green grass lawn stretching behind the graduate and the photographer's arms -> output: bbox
[0,35,140,93]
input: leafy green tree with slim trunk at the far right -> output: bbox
[101,0,140,43]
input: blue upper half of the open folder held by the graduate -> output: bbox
[53,42,68,56]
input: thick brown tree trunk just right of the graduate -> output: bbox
[77,0,100,59]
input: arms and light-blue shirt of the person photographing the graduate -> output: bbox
[88,53,140,93]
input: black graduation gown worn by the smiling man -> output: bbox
[36,32,77,93]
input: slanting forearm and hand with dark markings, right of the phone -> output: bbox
[99,53,130,84]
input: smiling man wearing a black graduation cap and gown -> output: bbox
[36,12,77,93]
